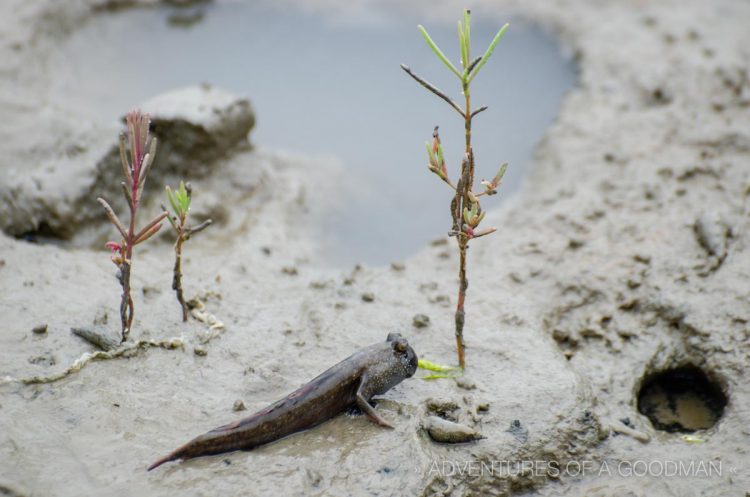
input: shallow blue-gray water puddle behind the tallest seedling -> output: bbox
[50,2,575,265]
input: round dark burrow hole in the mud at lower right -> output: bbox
[638,364,728,433]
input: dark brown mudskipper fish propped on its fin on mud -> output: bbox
[148,333,417,471]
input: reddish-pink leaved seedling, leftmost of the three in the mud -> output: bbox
[97,110,167,343]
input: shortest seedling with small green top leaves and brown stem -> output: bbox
[161,181,212,321]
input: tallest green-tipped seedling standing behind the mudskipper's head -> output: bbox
[401,10,508,370]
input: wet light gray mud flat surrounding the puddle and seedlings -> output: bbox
[0,0,750,496]
